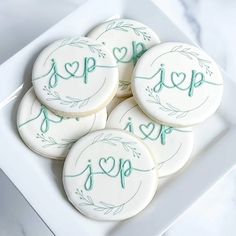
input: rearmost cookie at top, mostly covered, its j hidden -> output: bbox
[88,19,160,97]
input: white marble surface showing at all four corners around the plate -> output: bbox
[0,0,236,236]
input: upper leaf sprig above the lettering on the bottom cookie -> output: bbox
[92,133,141,158]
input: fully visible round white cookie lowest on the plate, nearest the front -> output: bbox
[63,129,158,220]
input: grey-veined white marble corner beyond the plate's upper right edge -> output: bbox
[155,0,236,77]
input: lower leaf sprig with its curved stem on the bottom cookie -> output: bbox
[75,182,142,215]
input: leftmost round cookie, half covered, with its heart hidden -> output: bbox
[17,88,107,160]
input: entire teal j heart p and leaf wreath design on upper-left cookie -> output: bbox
[32,37,117,108]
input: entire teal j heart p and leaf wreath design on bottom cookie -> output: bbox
[64,133,156,215]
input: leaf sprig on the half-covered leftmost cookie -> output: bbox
[36,133,76,149]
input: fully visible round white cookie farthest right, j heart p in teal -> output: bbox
[132,43,223,126]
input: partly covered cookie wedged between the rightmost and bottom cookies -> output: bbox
[106,97,193,177]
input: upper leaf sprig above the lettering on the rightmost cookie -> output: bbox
[170,45,213,76]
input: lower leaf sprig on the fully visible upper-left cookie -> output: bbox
[43,85,90,108]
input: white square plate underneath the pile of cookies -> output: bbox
[0,0,236,236]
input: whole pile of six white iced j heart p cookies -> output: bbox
[17,19,223,220]
